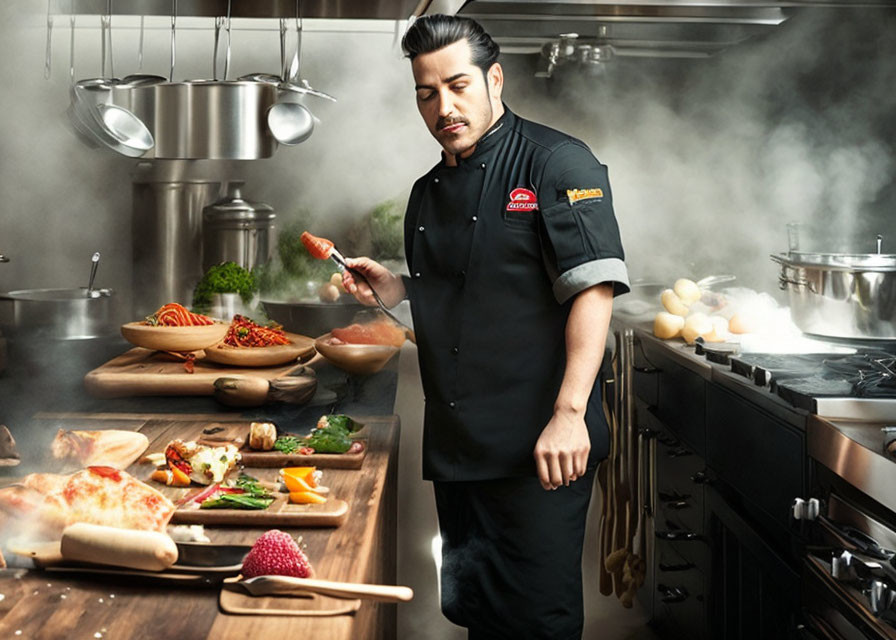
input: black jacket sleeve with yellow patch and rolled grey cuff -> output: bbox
[538,140,629,303]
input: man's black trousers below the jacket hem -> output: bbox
[433,468,595,640]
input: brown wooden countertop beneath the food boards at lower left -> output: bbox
[0,414,400,640]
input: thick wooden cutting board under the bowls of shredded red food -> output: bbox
[84,347,310,398]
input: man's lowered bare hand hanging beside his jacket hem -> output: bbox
[535,411,591,490]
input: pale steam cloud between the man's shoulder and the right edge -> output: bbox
[508,11,896,291]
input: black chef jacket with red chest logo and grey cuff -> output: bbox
[405,107,628,480]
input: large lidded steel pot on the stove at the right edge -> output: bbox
[771,251,896,340]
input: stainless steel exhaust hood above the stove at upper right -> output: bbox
[424,0,896,62]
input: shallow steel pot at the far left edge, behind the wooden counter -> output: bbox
[0,287,118,340]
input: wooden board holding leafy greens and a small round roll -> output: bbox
[182,422,367,469]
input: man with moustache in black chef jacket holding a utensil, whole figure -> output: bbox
[343,15,628,640]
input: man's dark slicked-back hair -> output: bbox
[401,13,501,73]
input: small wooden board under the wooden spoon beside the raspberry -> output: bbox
[218,580,361,616]
